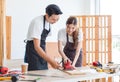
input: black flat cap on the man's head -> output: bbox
[46,4,62,16]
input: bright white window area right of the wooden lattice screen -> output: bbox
[100,0,120,63]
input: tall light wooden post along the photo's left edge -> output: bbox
[0,0,5,66]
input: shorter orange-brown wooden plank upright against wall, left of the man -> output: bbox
[6,16,11,59]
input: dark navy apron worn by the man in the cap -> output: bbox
[25,16,50,71]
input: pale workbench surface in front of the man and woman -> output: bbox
[1,67,120,82]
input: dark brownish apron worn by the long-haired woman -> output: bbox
[63,34,82,67]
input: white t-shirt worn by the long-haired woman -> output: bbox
[58,28,83,46]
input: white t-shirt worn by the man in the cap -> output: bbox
[27,15,51,41]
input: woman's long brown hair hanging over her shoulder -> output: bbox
[66,16,79,48]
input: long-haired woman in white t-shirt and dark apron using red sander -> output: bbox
[58,17,82,67]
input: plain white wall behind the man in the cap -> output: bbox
[6,0,90,59]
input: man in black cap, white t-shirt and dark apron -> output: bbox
[25,4,62,71]
